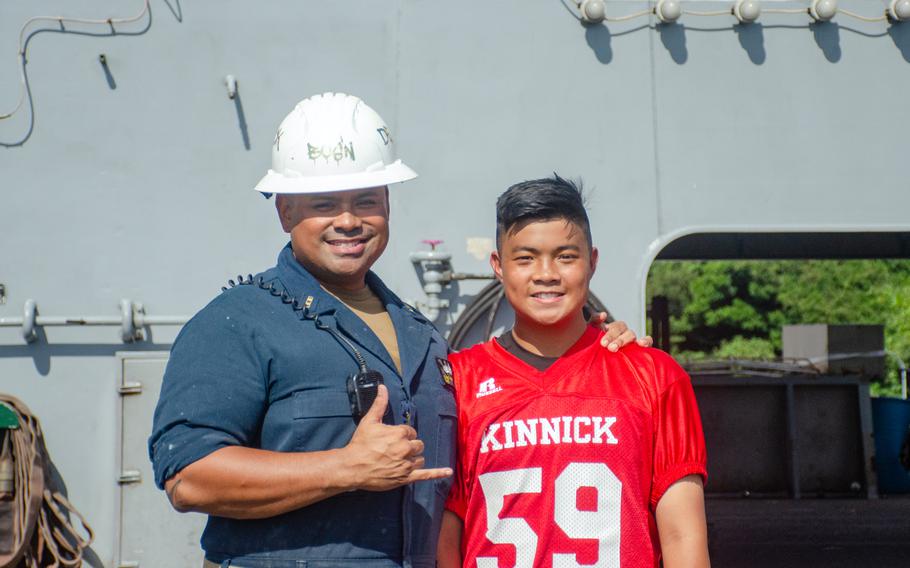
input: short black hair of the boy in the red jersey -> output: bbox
[496,172,593,249]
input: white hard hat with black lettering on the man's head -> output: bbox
[256,93,417,197]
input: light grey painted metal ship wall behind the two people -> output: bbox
[0,0,910,565]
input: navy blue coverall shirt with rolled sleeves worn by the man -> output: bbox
[149,245,464,568]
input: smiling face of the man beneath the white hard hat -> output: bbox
[275,186,389,290]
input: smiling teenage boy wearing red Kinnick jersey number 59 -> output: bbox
[438,175,709,568]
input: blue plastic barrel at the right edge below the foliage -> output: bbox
[872,397,910,493]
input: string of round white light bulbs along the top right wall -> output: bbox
[574,0,910,24]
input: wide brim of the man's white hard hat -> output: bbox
[255,160,417,194]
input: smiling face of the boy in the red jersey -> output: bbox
[490,219,597,326]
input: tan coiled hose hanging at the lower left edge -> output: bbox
[0,394,95,568]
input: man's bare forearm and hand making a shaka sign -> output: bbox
[165,386,452,519]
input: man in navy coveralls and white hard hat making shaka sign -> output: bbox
[149,93,634,568]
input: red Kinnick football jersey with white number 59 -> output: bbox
[446,328,707,568]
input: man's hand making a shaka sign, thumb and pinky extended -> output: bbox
[344,385,452,491]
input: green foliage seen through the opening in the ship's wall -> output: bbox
[647,260,910,395]
